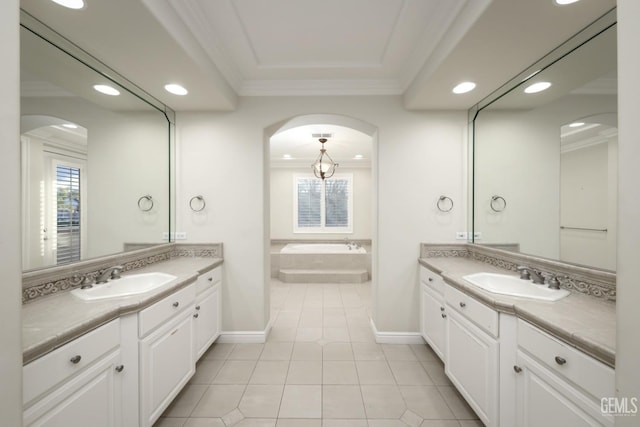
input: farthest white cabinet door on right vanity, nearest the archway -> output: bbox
[420,285,447,360]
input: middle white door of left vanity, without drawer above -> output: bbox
[140,306,195,427]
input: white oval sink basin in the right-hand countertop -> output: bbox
[462,273,569,301]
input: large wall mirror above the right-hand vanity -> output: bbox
[471,10,617,270]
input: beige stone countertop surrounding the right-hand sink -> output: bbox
[419,257,616,367]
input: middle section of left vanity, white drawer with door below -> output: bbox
[138,283,196,427]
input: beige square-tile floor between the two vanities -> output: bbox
[154,280,483,427]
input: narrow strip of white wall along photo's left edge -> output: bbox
[0,0,22,427]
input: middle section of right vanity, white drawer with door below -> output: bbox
[444,285,500,426]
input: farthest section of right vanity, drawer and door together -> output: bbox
[420,266,447,360]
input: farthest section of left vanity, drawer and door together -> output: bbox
[193,267,222,360]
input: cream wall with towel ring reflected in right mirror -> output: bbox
[474,95,617,259]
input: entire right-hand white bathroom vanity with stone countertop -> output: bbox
[419,245,615,427]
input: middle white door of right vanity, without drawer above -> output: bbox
[445,307,499,426]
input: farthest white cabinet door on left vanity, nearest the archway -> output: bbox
[193,285,220,359]
